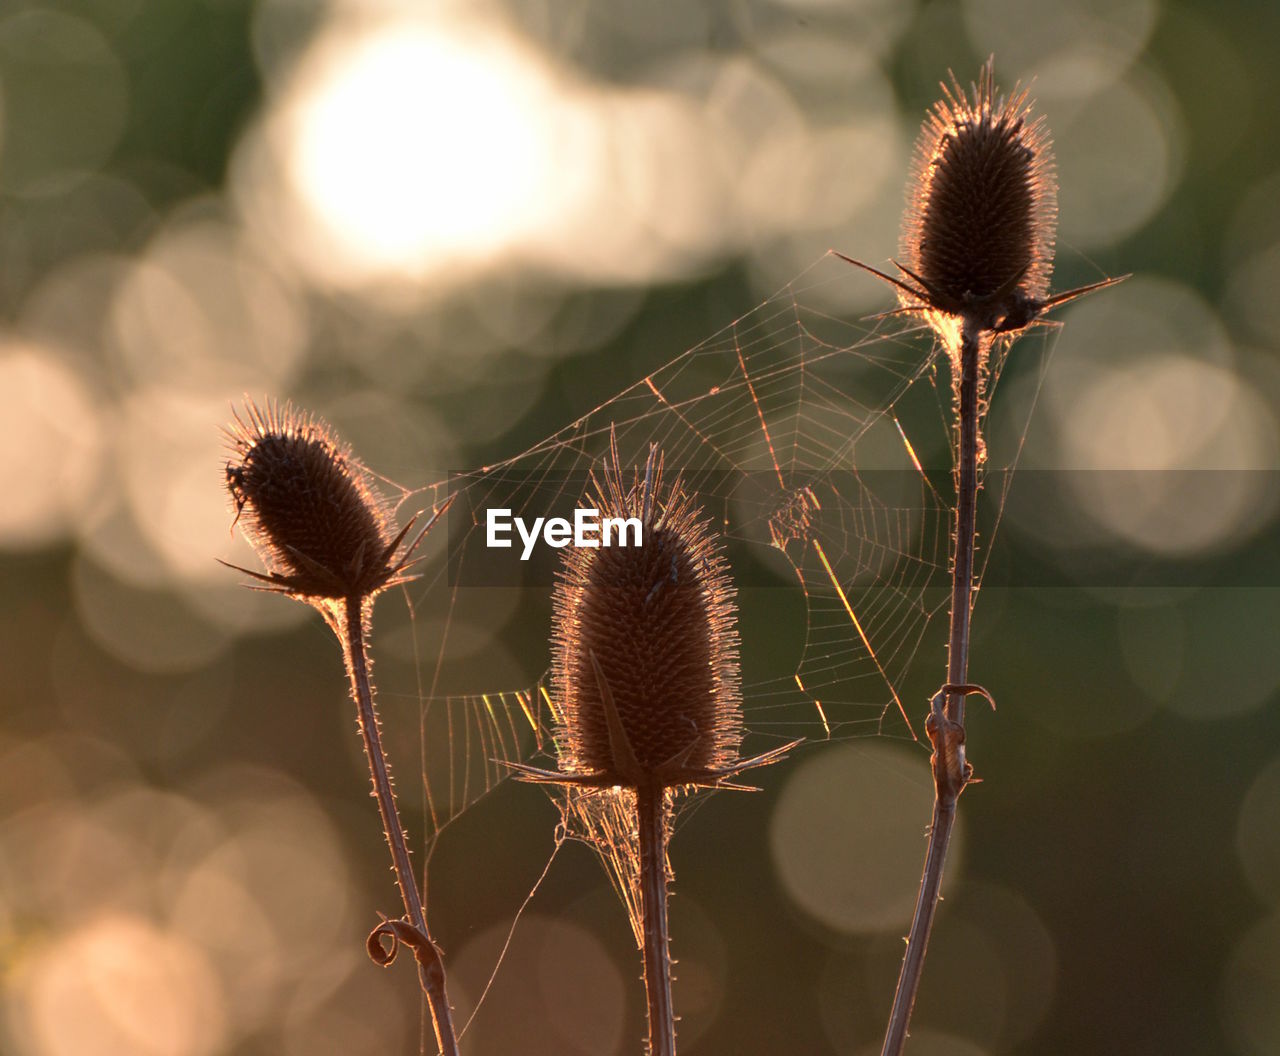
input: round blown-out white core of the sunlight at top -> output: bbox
[288,23,554,276]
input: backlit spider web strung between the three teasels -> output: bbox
[381,253,1050,855]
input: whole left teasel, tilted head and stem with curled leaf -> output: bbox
[224,402,458,1056]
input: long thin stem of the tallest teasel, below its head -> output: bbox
[881,321,980,1056]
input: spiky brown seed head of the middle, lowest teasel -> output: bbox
[552,452,742,786]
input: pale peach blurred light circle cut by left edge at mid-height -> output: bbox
[0,340,102,547]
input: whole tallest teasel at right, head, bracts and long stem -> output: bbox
[838,59,1128,1056]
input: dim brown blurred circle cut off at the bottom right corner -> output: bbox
[1221,914,1280,1056]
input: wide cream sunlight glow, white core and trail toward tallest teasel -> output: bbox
[240,9,905,300]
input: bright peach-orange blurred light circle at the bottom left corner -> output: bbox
[19,914,227,1056]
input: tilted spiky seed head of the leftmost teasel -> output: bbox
[225,402,398,599]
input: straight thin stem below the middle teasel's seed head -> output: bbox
[636,783,676,1056]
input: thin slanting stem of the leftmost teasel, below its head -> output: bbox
[343,596,458,1056]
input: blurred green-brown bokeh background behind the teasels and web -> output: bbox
[0,0,1280,1056]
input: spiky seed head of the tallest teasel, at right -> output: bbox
[899,59,1057,330]
